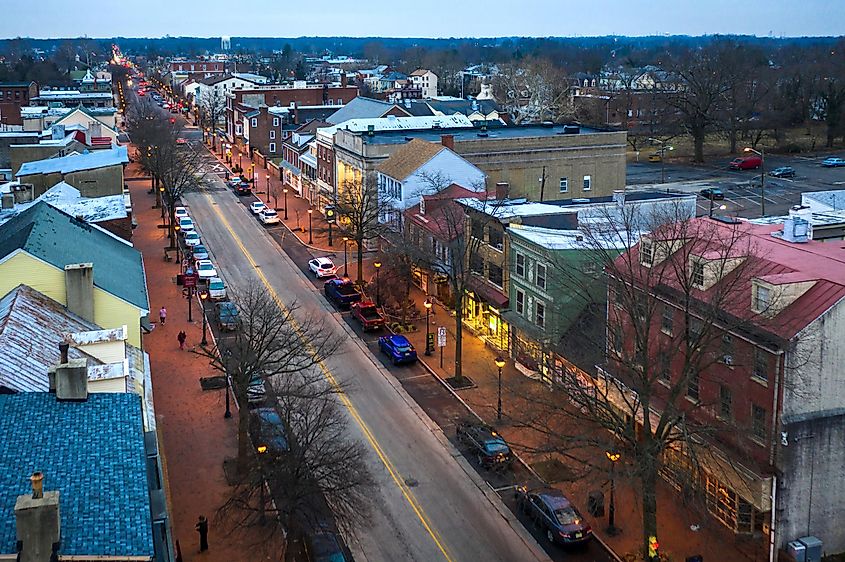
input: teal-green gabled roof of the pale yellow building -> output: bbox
[0,201,149,311]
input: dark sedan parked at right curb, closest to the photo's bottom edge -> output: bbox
[516,487,593,544]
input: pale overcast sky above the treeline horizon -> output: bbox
[0,0,845,37]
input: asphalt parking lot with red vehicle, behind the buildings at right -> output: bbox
[626,154,845,218]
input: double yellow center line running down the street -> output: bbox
[205,193,453,562]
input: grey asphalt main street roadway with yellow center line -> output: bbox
[184,132,547,561]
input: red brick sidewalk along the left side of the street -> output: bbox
[126,160,272,562]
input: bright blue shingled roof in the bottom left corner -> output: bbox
[0,392,153,558]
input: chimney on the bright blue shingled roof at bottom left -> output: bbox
[15,472,61,562]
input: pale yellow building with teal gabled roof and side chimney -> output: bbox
[0,202,149,347]
